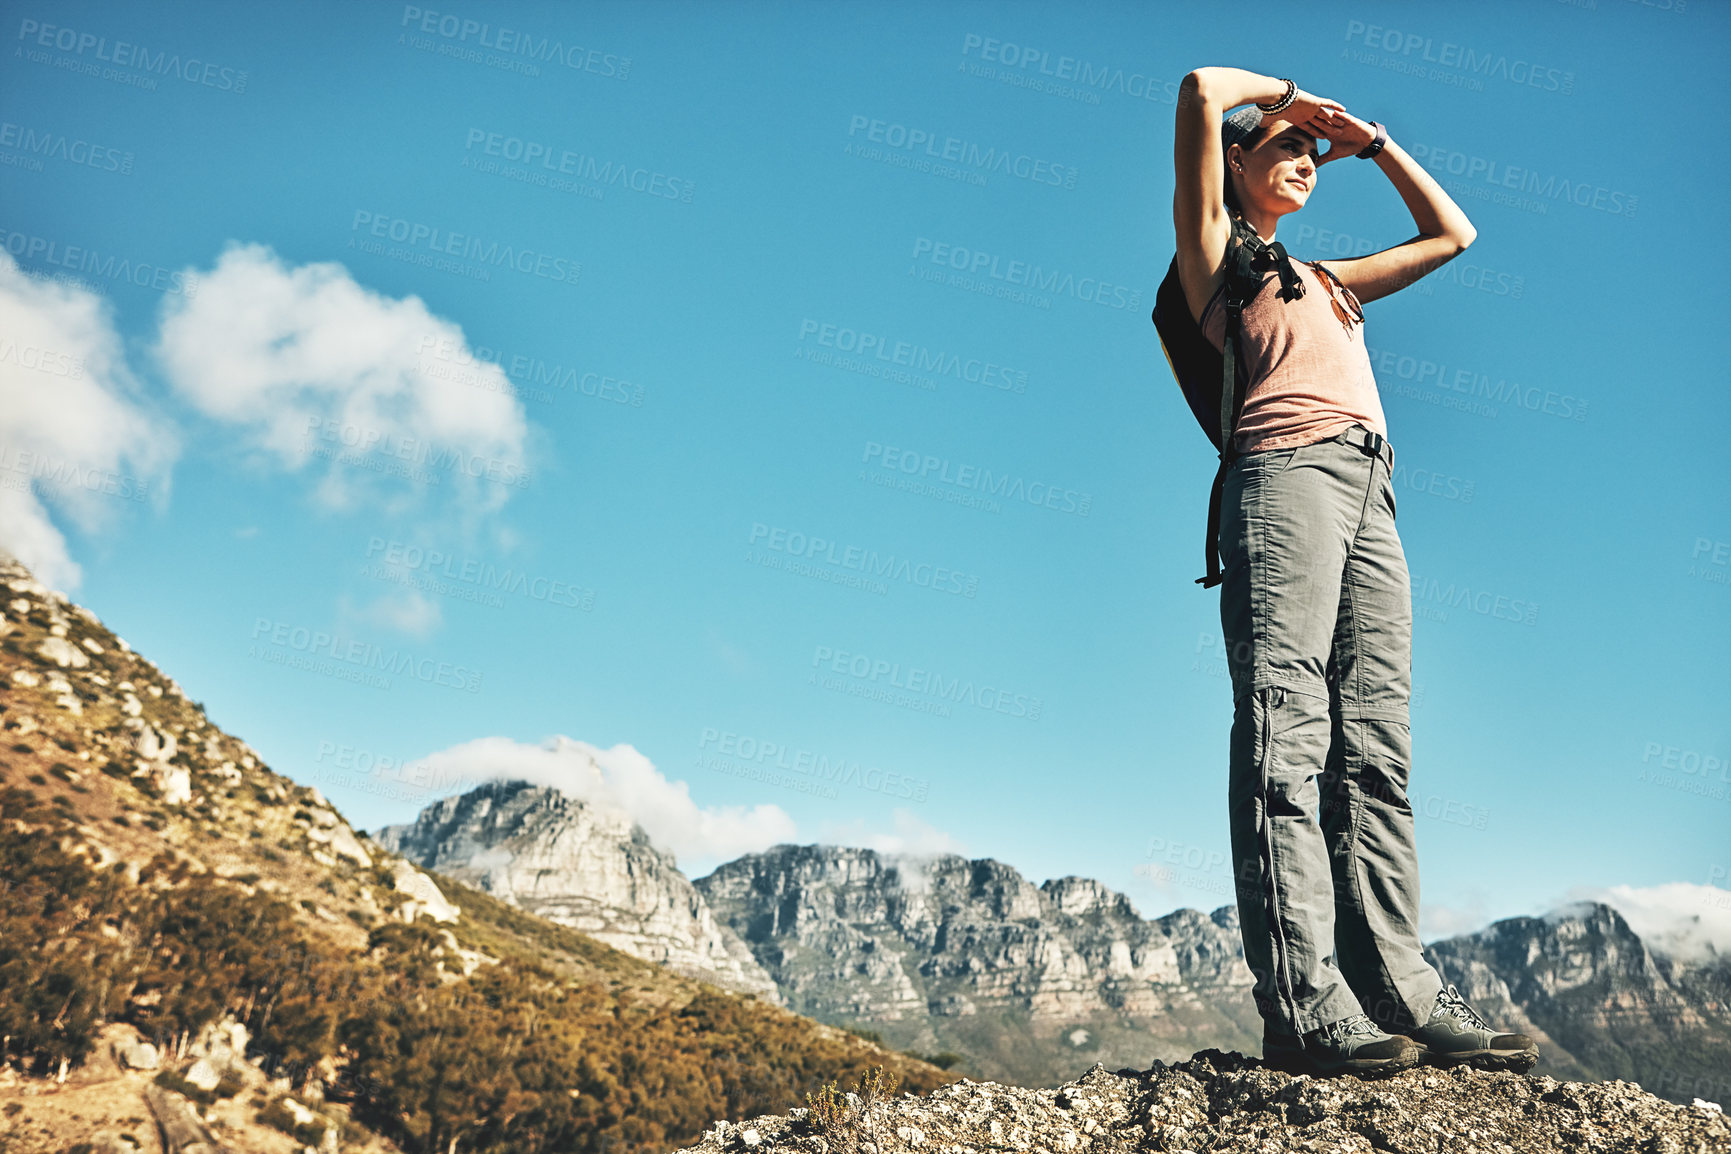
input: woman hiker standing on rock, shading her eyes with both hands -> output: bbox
[1172,67,1537,1074]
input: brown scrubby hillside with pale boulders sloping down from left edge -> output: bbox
[0,561,949,1154]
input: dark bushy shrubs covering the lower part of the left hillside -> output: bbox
[0,785,947,1154]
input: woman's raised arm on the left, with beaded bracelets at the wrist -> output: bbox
[1172,67,1342,317]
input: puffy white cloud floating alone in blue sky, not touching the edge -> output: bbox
[156,244,528,512]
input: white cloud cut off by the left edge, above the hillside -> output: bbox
[0,243,178,590]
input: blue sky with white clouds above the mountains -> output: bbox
[0,0,1731,934]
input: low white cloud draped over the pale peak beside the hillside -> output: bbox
[411,735,795,867]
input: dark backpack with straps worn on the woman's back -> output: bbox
[1155,215,1303,588]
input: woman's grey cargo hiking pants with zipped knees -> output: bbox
[1220,426,1442,1035]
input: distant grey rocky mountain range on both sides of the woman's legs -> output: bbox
[379,785,1731,1100]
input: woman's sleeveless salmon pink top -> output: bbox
[1201,260,1388,453]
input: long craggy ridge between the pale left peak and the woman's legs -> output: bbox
[696,846,1262,1085]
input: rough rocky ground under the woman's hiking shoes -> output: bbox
[671,1050,1731,1154]
